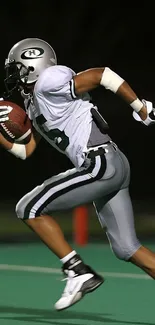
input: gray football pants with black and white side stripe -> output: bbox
[16,144,141,260]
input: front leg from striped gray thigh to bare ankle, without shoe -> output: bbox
[16,158,104,258]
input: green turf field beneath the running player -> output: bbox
[0,243,155,325]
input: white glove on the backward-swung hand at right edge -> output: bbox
[132,99,155,126]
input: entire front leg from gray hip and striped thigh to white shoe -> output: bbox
[16,144,139,310]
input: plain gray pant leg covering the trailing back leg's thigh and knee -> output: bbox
[95,188,141,261]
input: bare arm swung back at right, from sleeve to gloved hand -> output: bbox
[73,67,155,125]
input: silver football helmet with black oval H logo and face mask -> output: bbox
[4,38,57,96]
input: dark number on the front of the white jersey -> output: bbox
[36,114,69,151]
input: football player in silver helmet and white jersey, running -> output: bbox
[0,38,155,310]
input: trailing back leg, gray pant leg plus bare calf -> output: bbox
[95,188,155,279]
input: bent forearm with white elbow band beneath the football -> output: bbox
[0,131,41,160]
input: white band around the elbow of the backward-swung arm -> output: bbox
[100,67,124,93]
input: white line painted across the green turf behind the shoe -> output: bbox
[0,264,151,280]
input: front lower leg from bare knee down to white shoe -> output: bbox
[26,215,104,310]
